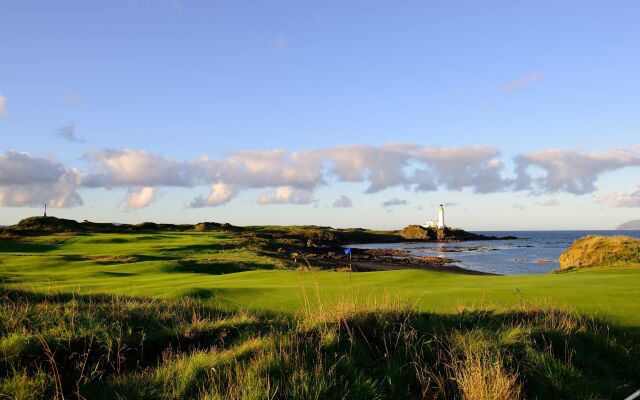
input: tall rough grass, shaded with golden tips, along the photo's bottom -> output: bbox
[0,287,640,399]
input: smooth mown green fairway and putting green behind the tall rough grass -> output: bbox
[0,232,640,326]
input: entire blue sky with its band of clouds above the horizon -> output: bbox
[0,0,640,230]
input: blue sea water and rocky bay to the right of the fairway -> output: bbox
[351,231,640,275]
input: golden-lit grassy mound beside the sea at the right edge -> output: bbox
[559,236,640,269]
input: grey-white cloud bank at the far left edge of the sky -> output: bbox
[0,151,82,207]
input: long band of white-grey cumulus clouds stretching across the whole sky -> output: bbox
[0,145,640,211]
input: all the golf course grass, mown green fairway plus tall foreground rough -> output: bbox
[0,228,640,399]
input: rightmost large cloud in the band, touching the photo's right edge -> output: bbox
[515,148,640,194]
